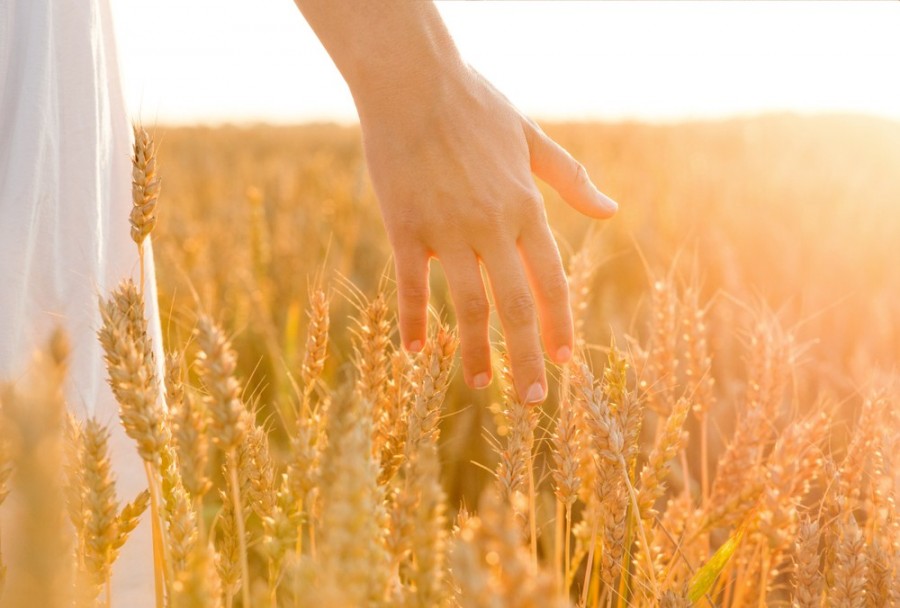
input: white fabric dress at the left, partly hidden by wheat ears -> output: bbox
[0,0,165,608]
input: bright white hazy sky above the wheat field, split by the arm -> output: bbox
[111,0,900,123]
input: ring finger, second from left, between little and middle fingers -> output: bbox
[440,250,491,388]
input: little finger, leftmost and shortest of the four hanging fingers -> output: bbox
[394,247,428,353]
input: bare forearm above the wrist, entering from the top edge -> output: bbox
[295,0,462,113]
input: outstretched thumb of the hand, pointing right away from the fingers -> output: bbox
[525,121,619,219]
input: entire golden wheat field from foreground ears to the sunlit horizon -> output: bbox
[0,115,900,608]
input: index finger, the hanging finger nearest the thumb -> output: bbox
[519,221,574,363]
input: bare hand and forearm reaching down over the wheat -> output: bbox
[296,0,618,403]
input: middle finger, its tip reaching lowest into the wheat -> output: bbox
[484,244,547,403]
